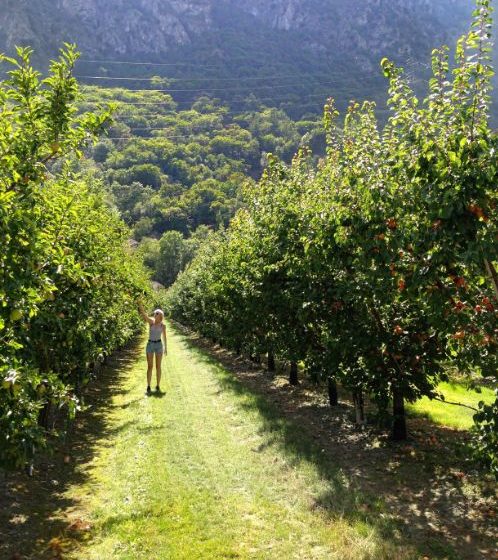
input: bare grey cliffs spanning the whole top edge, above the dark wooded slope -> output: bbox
[0,0,482,57]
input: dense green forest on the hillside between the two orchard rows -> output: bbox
[81,88,325,286]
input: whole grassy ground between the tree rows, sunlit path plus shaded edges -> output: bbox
[0,329,498,560]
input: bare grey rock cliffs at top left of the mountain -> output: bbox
[0,0,213,57]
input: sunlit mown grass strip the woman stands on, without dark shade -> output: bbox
[64,329,420,560]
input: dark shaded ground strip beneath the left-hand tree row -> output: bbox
[0,334,142,560]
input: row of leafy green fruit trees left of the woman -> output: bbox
[0,46,148,468]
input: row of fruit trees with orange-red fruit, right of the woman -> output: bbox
[169,0,498,472]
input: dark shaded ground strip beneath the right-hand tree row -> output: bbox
[177,326,496,560]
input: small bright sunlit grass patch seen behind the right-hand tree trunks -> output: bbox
[408,382,494,430]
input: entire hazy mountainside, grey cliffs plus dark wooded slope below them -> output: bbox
[0,0,498,117]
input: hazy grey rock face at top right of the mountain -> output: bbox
[232,0,478,64]
